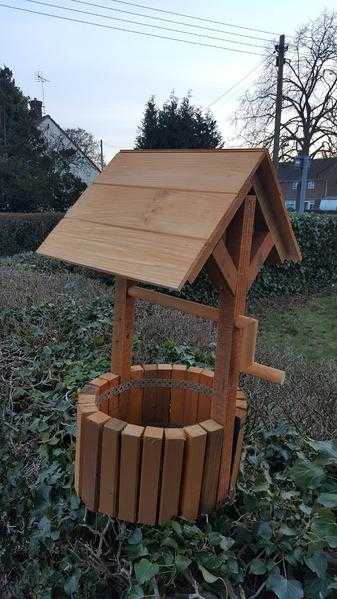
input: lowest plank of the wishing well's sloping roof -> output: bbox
[39,218,206,289]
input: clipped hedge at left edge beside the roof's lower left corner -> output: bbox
[0,212,63,256]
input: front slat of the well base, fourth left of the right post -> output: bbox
[138,426,164,524]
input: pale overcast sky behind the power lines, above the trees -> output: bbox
[0,0,336,158]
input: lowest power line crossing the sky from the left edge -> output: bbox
[0,3,262,56]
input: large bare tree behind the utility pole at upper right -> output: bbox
[235,11,337,160]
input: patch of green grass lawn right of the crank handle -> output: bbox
[260,293,337,360]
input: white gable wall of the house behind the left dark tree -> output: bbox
[38,115,99,185]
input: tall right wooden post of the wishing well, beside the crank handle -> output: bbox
[214,196,256,503]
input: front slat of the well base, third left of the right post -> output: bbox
[158,428,185,524]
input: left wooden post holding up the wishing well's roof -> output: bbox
[111,276,135,379]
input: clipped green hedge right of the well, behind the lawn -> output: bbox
[177,214,337,305]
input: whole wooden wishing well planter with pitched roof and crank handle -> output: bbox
[39,150,301,524]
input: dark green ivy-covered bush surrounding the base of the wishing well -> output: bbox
[0,294,337,599]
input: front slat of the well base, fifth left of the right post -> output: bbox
[118,424,144,522]
